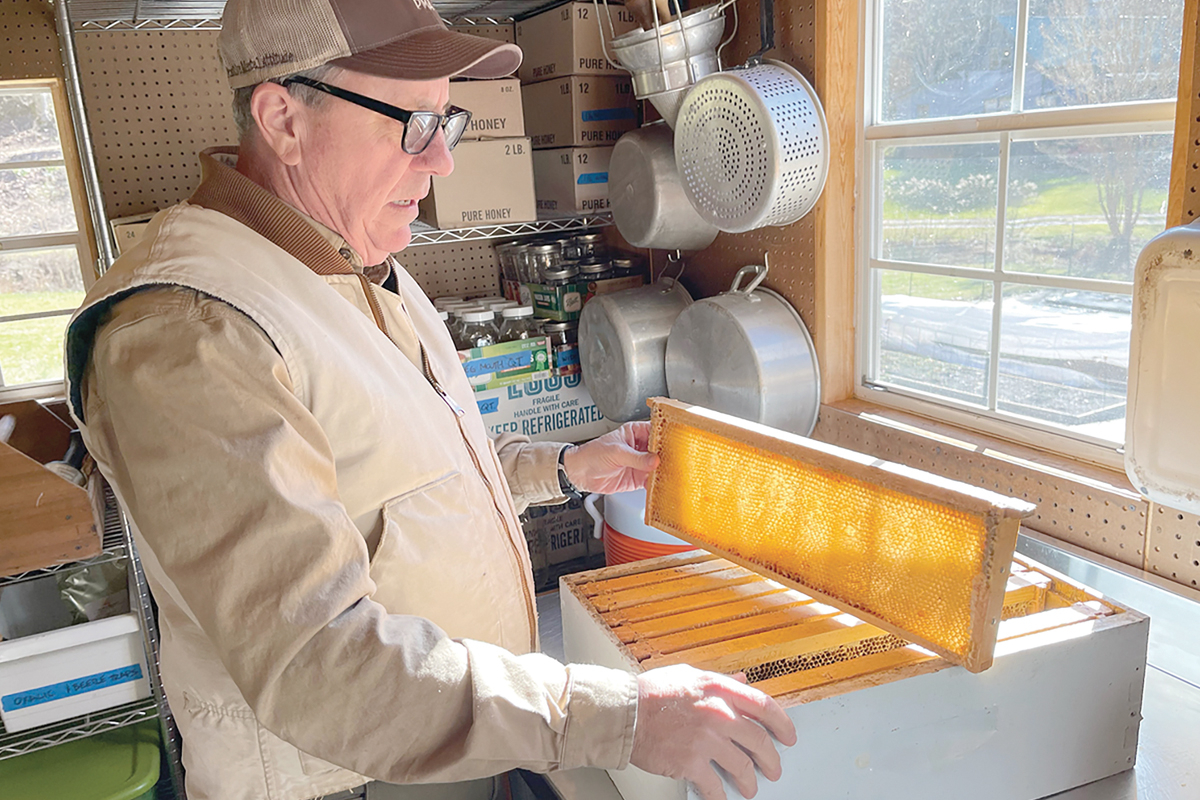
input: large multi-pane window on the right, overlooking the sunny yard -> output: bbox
[858,0,1183,457]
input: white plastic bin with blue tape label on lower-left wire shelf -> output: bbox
[0,614,150,733]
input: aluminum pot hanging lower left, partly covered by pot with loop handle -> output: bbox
[580,278,691,422]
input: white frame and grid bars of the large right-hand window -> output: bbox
[854,0,1176,470]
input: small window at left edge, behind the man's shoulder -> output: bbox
[0,82,90,391]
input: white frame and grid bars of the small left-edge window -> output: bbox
[0,78,92,403]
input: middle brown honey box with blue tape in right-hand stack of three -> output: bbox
[521,76,637,149]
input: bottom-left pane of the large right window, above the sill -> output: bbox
[875,270,992,405]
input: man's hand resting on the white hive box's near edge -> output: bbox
[629,664,796,800]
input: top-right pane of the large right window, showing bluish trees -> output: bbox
[1025,0,1183,109]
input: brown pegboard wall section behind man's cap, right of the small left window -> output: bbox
[76,30,238,218]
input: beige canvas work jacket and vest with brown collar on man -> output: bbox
[67,149,637,800]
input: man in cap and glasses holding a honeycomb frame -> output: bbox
[67,0,794,800]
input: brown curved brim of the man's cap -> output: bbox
[331,28,521,80]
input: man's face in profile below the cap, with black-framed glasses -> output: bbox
[293,72,454,265]
